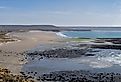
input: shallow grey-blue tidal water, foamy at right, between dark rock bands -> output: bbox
[23,49,121,75]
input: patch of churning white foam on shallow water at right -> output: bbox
[74,49,121,68]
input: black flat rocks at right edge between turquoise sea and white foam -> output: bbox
[76,39,121,50]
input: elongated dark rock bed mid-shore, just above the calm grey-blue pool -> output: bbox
[27,48,88,58]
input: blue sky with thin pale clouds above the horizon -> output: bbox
[0,0,121,26]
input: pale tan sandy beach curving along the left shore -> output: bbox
[0,31,61,74]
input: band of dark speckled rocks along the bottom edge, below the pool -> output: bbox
[40,70,121,82]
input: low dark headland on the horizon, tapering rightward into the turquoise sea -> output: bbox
[0,25,90,32]
